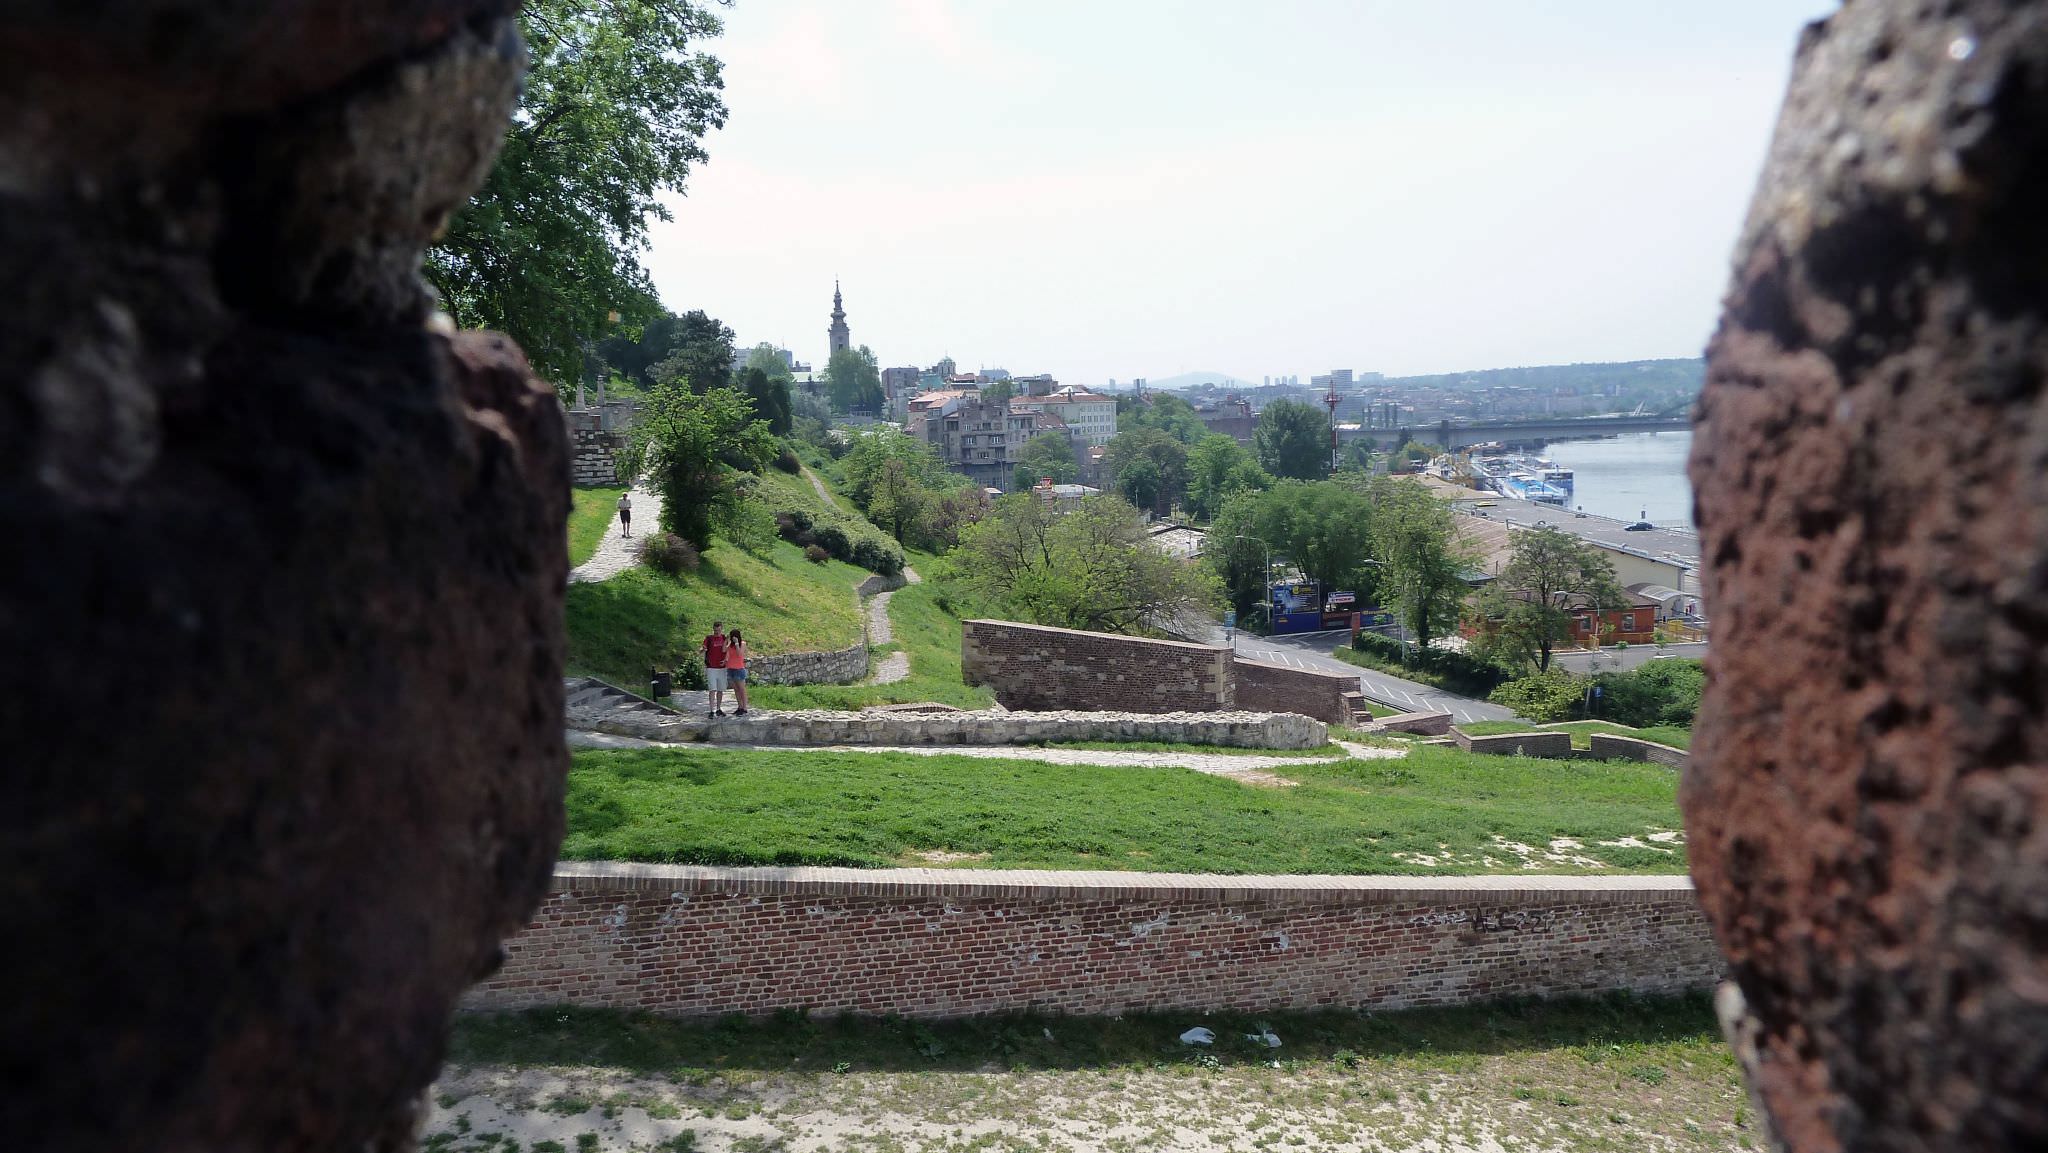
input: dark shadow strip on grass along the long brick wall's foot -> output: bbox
[449,993,1718,1079]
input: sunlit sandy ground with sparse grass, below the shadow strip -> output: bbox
[424,1051,1753,1153]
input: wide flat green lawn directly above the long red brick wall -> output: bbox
[561,745,1686,874]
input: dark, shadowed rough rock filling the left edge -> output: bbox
[0,0,567,1153]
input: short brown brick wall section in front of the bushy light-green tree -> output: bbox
[961,621,1233,713]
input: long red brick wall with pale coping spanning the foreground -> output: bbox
[465,864,1720,1018]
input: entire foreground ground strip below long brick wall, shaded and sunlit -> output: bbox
[436,995,1757,1153]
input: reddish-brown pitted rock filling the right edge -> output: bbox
[1683,0,2048,1151]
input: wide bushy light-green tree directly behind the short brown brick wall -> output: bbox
[954,494,1219,635]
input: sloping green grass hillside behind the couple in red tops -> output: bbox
[567,540,868,688]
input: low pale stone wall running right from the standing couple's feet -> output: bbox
[569,707,1329,750]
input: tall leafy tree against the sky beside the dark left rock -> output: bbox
[424,0,725,387]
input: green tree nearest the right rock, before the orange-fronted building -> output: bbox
[1475,528,1628,672]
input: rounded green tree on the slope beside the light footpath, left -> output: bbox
[623,385,776,551]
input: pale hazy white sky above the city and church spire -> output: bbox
[647,0,1833,383]
